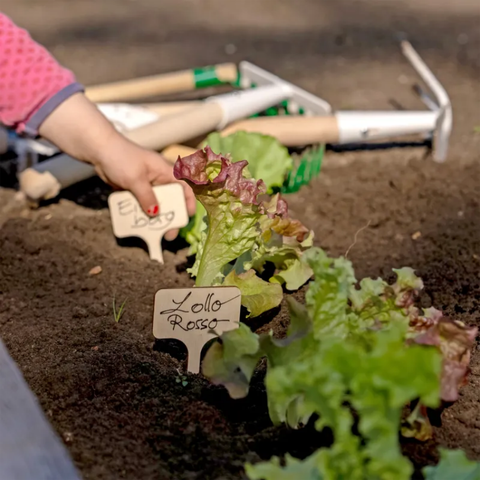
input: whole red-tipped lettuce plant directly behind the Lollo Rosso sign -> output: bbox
[174,147,313,316]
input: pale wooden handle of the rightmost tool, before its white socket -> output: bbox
[221,115,339,147]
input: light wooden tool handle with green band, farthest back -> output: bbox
[85,63,237,103]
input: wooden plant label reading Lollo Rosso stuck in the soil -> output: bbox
[153,287,242,373]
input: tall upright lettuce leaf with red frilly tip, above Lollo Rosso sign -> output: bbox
[174,147,265,286]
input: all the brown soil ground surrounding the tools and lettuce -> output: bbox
[0,0,480,480]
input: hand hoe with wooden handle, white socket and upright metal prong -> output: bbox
[221,41,452,163]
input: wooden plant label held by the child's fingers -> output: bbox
[108,183,188,263]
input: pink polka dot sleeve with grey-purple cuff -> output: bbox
[0,13,83,136]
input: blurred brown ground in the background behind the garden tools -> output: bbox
[1,0,480,119]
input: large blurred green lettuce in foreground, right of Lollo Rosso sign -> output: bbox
[204,249,477,480]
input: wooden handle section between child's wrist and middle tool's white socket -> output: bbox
[125,102,223,150]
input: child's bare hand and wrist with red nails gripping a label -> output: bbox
[39,93,196,240]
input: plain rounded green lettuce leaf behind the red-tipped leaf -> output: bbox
[202,131,293,193]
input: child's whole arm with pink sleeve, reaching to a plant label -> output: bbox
[0,13,195,227]
